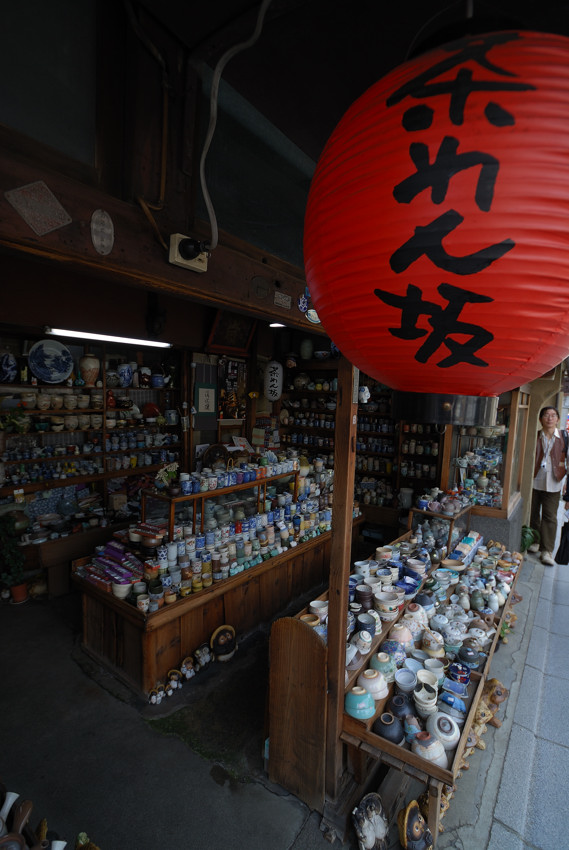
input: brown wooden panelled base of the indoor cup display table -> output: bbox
[73,518,363,694]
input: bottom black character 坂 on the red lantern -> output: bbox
[374,283,494,368]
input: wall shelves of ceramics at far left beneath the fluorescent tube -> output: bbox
[0,340,188,506]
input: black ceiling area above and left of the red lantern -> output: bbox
[139,0,569,161]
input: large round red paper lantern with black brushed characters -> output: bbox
[304,32,569,396]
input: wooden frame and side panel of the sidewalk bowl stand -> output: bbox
[269,548,519,843]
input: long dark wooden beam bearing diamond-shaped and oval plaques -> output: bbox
[0,150,316,333]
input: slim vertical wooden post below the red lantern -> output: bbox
[326,358,359,800]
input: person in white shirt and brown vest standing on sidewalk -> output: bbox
[529,407,569,567]
